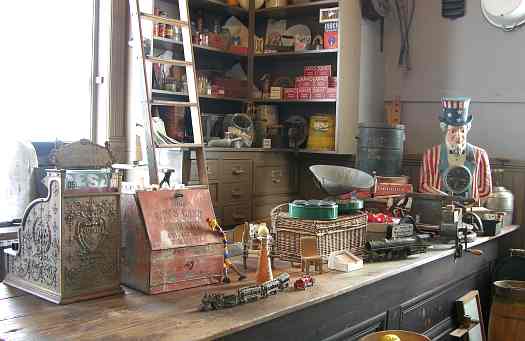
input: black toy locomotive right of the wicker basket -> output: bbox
[364,237,429,262]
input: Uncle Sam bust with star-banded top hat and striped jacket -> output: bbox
[419,97,492,201]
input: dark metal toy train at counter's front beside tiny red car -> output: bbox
[201,272,290,311]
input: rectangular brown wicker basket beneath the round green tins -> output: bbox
[271,204,367,262]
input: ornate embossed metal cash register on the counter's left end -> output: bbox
[4,140,122,304]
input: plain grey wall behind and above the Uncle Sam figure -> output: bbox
[385,0,525,160]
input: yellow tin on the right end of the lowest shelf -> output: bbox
[307,115,335,151]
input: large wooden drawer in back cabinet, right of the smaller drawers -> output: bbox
[255,164,291,195]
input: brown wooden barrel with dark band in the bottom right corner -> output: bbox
[489,280,525,341]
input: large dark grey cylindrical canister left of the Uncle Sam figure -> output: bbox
[356,123,405,176]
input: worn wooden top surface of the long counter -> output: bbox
[0,226,518,341]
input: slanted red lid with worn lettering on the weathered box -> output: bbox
[137,188,221,250]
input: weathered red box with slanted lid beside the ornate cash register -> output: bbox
[121,183,224,294]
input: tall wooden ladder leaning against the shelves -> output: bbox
[129,0,208,185]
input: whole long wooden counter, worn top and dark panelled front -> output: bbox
[0,227,517,341]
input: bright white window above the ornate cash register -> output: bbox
[0,0,98,141]
